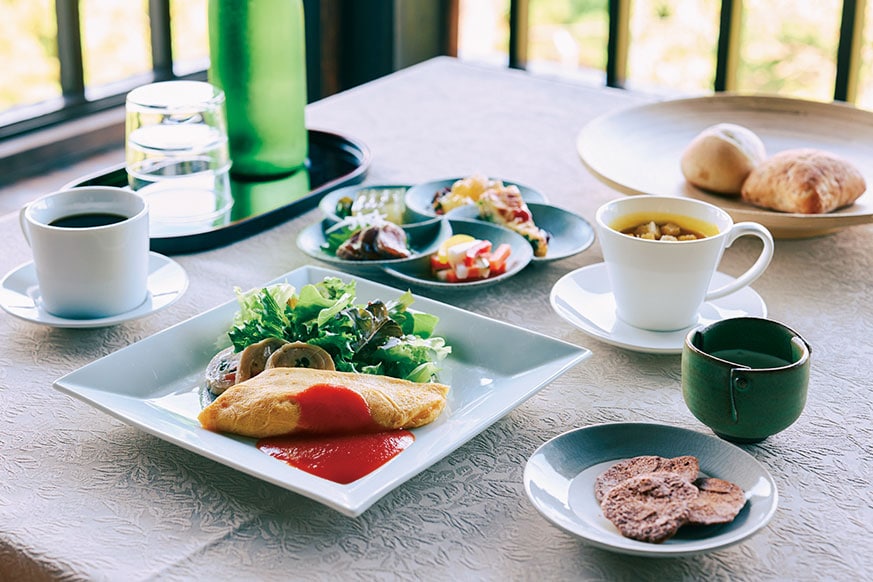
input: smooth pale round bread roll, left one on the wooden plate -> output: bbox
[680,123,767,196]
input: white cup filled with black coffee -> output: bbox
[19,186,149,319]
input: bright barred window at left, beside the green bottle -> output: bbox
[0,0,208,138]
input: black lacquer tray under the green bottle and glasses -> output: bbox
[65,129,370,254]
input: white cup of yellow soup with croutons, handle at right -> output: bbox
[596,195,774,331]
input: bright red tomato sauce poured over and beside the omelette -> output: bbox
[257,384,415,485]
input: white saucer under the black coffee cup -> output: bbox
[0,253,188,328]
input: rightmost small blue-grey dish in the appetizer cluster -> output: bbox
[446,202,594,262]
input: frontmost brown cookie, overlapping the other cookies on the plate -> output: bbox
[601,473,698,544]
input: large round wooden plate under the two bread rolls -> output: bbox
[576,95,873,238]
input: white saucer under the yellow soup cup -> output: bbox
[551,263,767,354]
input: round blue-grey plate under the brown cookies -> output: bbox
[524,423,779,558]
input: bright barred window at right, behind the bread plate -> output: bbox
[458,0,873,108]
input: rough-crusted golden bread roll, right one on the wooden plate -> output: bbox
[742,148,867,214]
